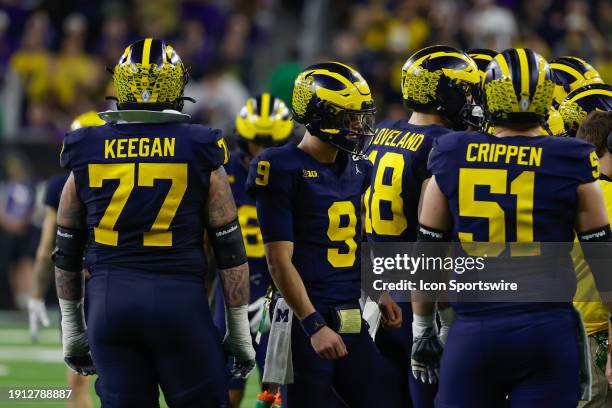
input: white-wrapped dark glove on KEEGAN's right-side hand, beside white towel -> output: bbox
[223,305,255,378]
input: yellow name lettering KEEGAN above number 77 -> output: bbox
[104,137,176,159]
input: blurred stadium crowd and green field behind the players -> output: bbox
[0,0,612,407]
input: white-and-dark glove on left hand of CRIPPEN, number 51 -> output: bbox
[410,314,442,384]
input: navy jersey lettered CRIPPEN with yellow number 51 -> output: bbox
[429,132,599,311]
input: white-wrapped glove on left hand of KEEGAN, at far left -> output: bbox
[59,298,96,375]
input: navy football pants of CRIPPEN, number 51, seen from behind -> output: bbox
[436,308,580,408]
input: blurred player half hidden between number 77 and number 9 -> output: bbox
[215,92,293,407]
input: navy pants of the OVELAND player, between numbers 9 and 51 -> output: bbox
[376,302,438,408]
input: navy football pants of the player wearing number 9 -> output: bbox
[282,305,398,408]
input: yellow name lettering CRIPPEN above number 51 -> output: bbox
[465,143,542,167]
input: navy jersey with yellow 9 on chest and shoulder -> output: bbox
[247,145,371,304]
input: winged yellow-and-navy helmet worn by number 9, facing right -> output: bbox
[291,62,376,156]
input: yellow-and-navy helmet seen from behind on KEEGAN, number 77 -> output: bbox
[113,38,189,111]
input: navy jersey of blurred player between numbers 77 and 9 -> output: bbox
[225,151,272,303]
